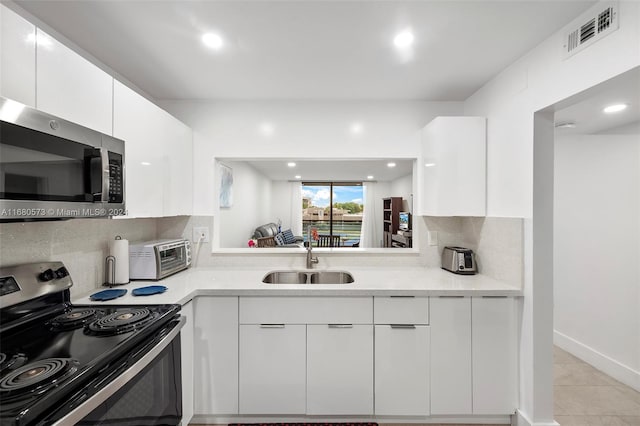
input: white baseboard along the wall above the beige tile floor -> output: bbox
[553,330,640,392]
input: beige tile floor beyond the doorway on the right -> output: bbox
[553,347,640,426]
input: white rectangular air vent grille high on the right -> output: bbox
[563,2,619,59]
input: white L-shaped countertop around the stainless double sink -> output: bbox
[72,267,522,305]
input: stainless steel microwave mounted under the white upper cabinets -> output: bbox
[0,97,126,222]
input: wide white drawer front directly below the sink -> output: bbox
[239,296,373,324]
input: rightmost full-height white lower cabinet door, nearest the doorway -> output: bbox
[471,297,517,414]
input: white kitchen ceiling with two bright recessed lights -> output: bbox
[15,0,595,101]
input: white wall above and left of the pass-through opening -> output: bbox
[161,101,462,215]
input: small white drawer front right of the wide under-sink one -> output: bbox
[373,296,429,324]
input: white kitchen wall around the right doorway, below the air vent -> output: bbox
[464,1,640,425]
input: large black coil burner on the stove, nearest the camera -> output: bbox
[0,358,78,399]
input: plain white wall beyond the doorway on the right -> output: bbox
[554,134,640,390]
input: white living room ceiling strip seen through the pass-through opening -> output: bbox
[242,159,413,182]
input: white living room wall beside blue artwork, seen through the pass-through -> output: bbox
[218,161,275,248]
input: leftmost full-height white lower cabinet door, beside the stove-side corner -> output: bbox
[193,297,238,415]
